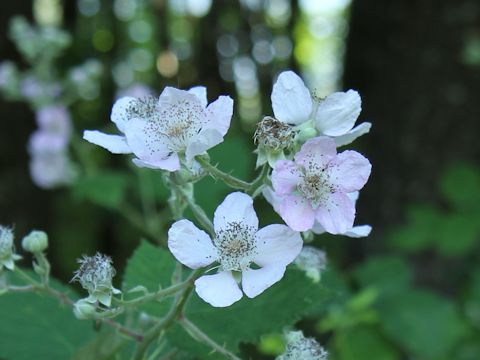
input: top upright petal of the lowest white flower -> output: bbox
[213,192,258,233]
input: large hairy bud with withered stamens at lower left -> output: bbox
[71,253,120,306]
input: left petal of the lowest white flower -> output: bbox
[168,220,218,269]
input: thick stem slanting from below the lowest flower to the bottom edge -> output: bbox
[134,269,203,360]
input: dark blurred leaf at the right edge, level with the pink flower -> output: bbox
[440,163,480,211]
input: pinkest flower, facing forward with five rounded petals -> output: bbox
[272,136,371,234]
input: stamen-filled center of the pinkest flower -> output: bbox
[297,169,335,209]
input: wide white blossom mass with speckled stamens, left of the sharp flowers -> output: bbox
[83,87,233,171]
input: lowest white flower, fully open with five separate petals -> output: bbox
[168,192,303,307]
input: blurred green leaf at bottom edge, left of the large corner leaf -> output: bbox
[335,327,400,360]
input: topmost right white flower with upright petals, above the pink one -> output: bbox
[271,71,372,146]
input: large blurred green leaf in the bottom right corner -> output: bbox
[379,290,467,359]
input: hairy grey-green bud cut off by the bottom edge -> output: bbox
[276,331,328,360]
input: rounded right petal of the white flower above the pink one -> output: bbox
[315,90,362,136]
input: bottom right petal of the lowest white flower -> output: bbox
[242,265,285,298]
